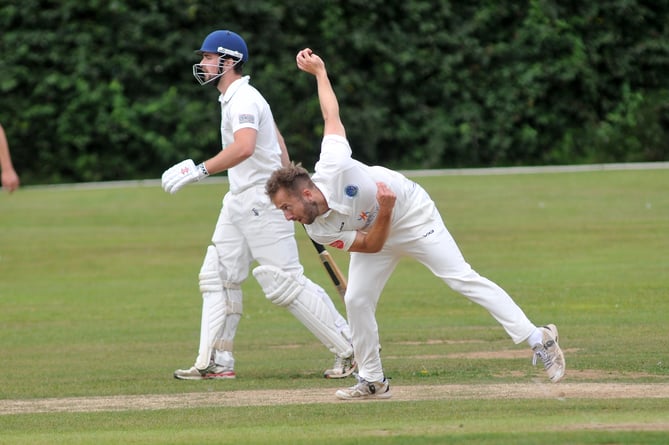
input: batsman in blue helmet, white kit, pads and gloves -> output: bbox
[162,30,355,380]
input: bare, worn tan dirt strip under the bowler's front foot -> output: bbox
[0,381,669,414]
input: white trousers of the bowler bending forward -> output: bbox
[346,187,536,382]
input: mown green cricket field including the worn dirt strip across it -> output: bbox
[0,170,669,444]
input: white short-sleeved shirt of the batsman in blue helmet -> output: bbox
[218,76,281,193]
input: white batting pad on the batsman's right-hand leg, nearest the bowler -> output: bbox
[253,266,353,357]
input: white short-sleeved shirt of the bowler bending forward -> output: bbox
[306,135,426,250]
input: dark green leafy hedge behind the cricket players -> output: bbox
[0,0,669,184]
